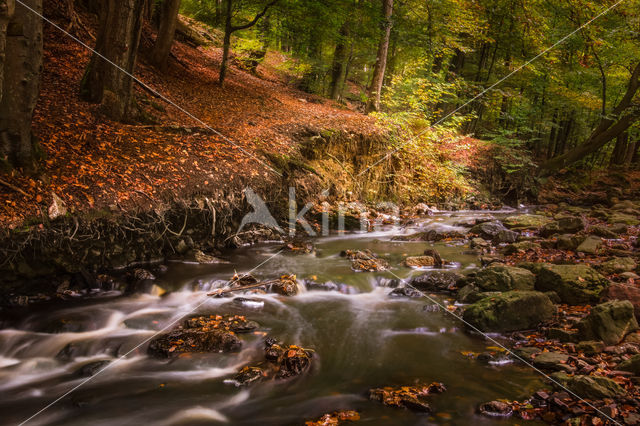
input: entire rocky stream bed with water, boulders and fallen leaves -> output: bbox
[0,200,640,424]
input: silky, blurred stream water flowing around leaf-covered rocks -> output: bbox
[0,212,541,425]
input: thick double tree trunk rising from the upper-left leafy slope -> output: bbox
[80,0,145,121]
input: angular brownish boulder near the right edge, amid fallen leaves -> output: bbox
[577,300,638,345]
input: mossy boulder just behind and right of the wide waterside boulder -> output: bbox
[534,264,609,305]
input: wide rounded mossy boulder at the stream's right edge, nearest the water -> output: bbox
[463,291,556,332]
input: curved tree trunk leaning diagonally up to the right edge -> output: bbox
[540,62,640,174]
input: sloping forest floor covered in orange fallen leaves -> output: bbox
[0,0,379,229]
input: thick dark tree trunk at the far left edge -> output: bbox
[0,0,42,170]
